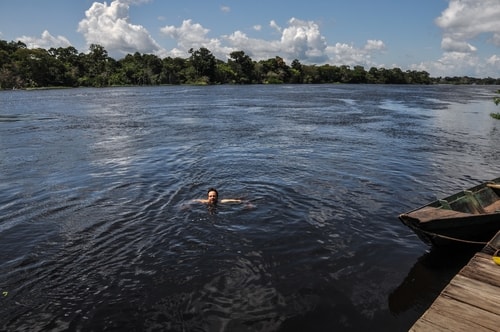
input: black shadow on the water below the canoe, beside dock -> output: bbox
[388,246,481,315]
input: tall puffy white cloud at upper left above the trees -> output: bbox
[78,0,162,56]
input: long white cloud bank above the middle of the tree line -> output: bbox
[161,18,385,65]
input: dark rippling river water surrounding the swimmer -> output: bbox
[0,85,500,331]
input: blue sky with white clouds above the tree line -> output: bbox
[0,0,500,78]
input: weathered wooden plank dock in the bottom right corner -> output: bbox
[410,232,500,332]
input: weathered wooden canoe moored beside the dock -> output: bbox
[399,178,500,246]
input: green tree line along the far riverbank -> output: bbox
[0,40,500,89]
